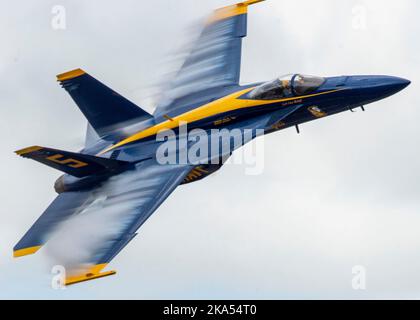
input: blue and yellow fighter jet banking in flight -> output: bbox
[14,0,410,284]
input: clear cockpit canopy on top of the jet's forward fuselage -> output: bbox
[249,74,325,100]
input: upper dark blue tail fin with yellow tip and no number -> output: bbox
[57,69,152,137]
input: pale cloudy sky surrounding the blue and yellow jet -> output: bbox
[0,0,420,299]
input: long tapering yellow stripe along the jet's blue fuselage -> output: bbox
[98,87,341,155]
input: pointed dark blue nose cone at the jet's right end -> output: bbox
[348,76,411,102]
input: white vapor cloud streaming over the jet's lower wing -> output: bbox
[47,164,187,273]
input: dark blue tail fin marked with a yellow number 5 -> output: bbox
[16,146,129,178]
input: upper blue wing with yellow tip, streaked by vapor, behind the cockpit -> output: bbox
[155,0,264,117]
